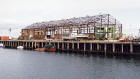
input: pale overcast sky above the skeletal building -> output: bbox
[0,0,140,37]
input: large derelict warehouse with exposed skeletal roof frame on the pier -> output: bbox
[19,14,122,40]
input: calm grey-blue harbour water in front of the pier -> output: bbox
[0,49,140,79]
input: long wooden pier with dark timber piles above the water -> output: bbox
[0,40,140,54]
